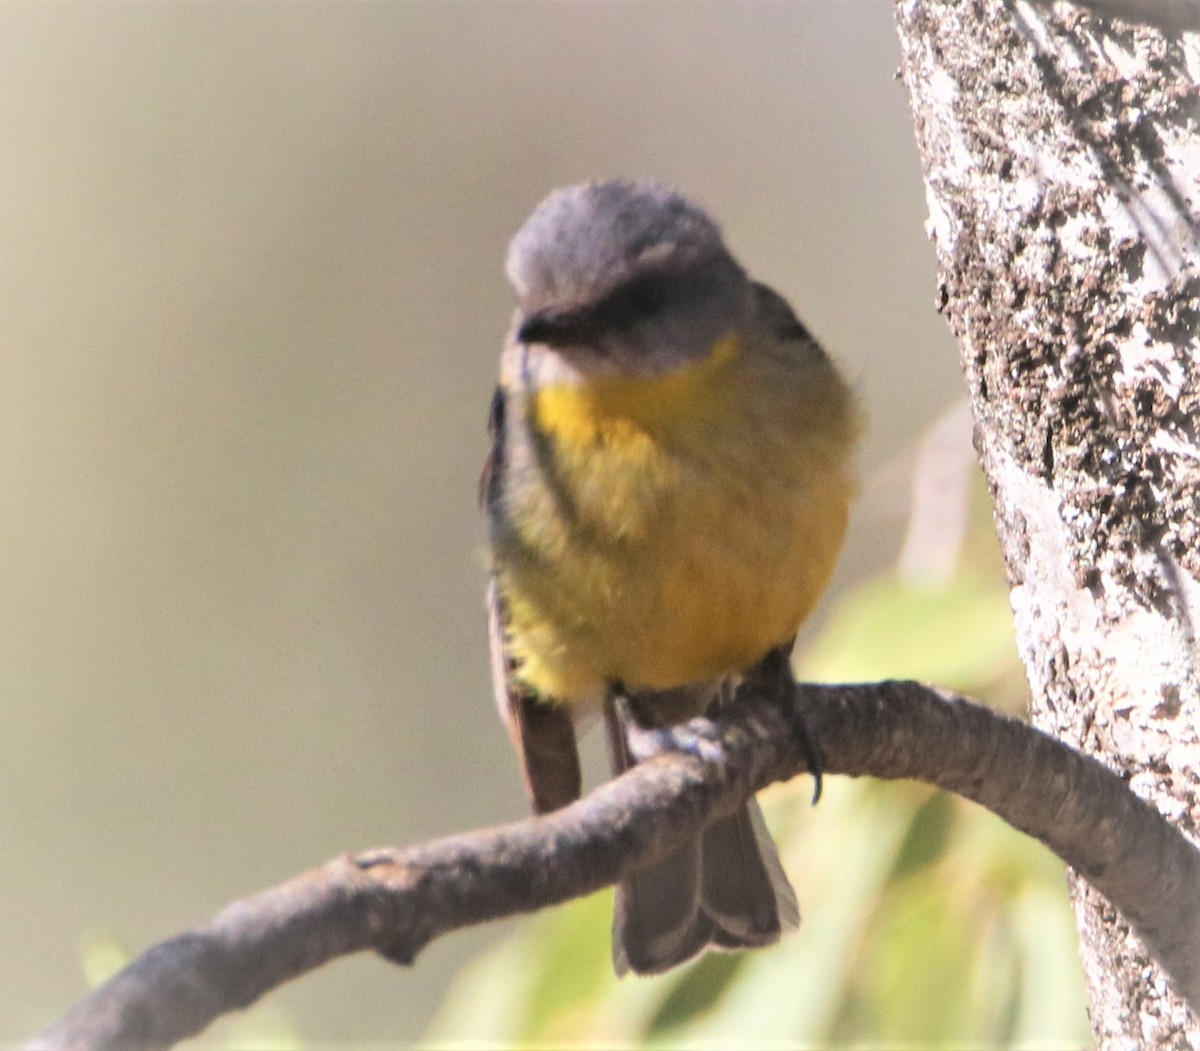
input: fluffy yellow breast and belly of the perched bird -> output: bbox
[497,336,854,701]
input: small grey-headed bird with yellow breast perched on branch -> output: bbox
[480,179,860,974]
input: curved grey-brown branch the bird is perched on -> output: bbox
[31,683,1200,1049]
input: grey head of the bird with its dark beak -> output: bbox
[506,181,750,372]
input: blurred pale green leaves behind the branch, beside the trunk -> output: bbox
[425,470,1090,1049]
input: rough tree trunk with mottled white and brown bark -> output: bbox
[896,0,1200,1049]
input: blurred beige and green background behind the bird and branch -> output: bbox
[0,0,1084,1046]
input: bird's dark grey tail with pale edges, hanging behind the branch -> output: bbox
[605,695,800,975]
